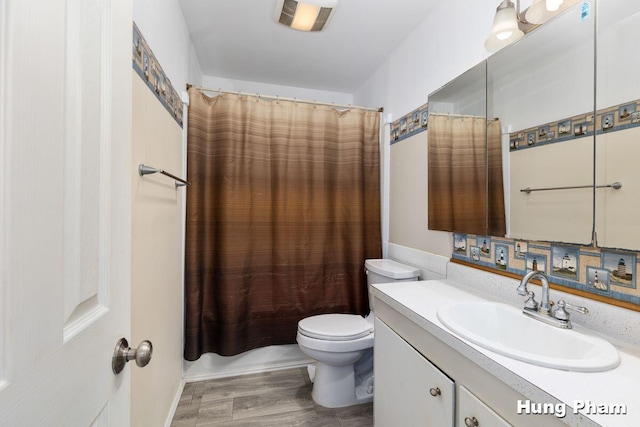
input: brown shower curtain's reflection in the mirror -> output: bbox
[428,114,506,236]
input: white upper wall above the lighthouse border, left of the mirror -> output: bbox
[354,0,499,119]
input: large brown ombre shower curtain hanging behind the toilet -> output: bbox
[184,88,381,360]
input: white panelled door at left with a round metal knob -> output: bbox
[0,0,132,427]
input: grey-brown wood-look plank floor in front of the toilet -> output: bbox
[171,368,373,427]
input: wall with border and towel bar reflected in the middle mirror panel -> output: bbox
[487,0,595,244]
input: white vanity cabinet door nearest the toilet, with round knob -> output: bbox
[373,319,455,427]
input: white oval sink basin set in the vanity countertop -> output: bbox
[438,302,620,372]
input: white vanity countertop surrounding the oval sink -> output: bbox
[372,280,640,427]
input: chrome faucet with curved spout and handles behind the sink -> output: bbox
[517,270,589,329]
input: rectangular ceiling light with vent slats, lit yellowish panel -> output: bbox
[274,0,338,31]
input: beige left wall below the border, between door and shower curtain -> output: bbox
[130,74,186,427]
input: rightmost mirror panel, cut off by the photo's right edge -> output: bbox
[596,0,640,250]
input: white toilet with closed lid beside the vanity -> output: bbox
[296,259,420,408]
